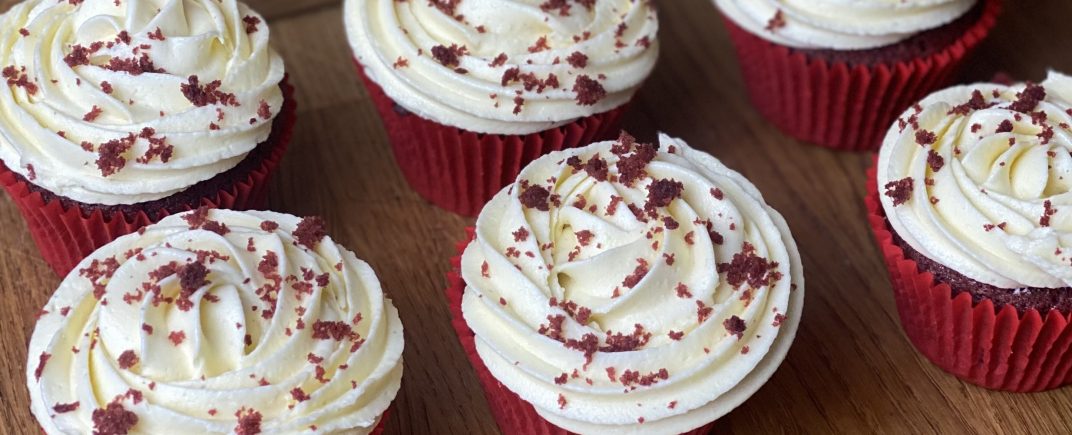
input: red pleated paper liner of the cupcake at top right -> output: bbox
[724,0,1001,151]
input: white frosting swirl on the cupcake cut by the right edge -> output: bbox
[878,73,1072,289]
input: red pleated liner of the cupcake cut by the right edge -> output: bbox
[865,162,1072,392]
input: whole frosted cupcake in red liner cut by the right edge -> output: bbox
[867,73,1072,392]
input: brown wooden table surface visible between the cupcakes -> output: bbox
[0,0,1072,434]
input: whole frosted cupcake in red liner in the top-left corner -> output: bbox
[0,0,295,275]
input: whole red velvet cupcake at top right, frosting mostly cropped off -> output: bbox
[714,0,1001,150]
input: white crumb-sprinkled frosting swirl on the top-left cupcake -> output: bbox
[0,0,283,205]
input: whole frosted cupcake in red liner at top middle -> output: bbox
[344,0,659,216]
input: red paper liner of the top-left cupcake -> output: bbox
[0,79,297,276]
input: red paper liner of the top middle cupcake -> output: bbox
[355,60,627,216]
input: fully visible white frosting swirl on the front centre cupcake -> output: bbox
[461,135,804,433]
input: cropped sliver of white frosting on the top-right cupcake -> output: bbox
[715,0,976,50]
